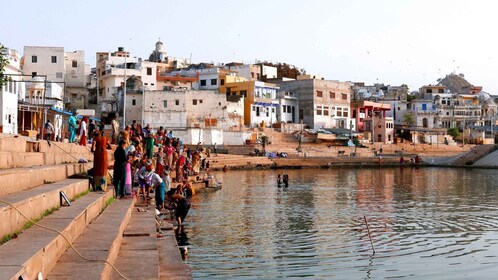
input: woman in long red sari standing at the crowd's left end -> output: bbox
[92,130,111,191]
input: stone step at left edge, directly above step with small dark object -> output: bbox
[0,163,91,196]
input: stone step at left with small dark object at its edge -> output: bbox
[0,179,89,243]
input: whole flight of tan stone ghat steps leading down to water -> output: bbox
[0,135,191,280]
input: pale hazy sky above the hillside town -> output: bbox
[0,0,498,94]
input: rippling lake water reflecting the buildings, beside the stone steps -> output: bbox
[180,168,498,279]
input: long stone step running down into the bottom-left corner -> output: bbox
[0,192,112,280]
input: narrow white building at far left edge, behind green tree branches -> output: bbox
[0,49,26,134]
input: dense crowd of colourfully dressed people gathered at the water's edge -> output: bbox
[90,120,214,224]
